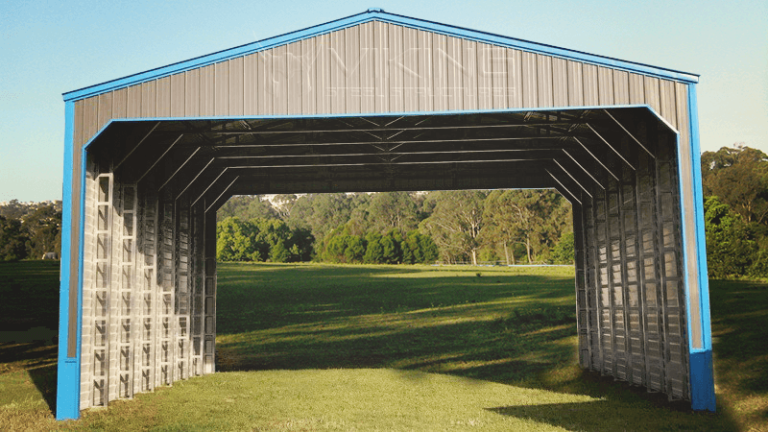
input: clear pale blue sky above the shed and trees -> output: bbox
[0,0,768,201]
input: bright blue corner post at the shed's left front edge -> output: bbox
[56,101,82,420]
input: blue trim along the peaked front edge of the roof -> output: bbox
[63,8,699,101]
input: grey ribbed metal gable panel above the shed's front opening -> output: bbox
[75,22,687,149]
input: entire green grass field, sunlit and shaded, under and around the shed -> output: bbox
[0,262,768,431]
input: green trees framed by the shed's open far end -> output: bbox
[218,190,573,264]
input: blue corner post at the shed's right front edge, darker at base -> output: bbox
[688,84,715,412]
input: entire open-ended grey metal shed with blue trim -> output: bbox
[57,6,714,418]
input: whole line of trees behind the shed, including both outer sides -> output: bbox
[0,145,768,278]
